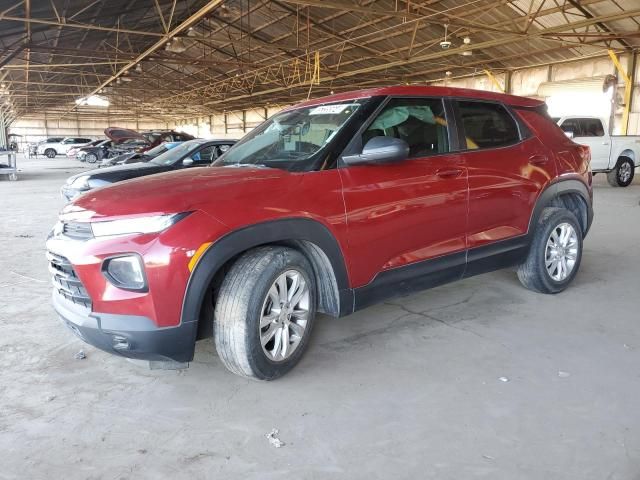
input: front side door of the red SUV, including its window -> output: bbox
[339,97,468,294]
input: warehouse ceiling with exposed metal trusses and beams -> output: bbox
[0,0,640,119]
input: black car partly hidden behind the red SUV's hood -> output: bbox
[62,139,235,201]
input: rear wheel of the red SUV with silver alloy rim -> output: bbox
[518,208,583,293]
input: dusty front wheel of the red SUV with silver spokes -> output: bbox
[213,246,316,380]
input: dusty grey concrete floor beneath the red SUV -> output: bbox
[0,157,640,480]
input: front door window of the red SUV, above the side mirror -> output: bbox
[362,98,449,158]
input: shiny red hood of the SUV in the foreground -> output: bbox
[65,163,304,223]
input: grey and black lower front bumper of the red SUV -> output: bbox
[53,291,197,363]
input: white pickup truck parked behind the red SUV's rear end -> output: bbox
[554,116,640,187]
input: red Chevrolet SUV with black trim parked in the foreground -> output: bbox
[47,87,593,380]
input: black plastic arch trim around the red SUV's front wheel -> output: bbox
[181,218,353,326]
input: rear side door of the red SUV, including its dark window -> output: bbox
[456,99,555,268]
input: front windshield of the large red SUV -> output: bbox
[213,100,364,170]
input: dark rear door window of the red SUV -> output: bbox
[458,101,520,150]
